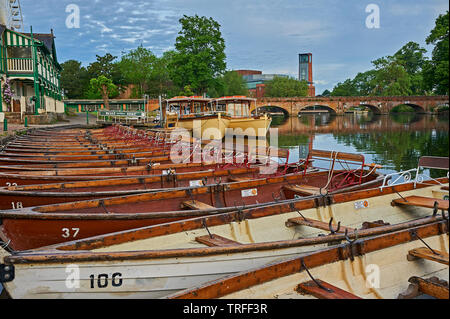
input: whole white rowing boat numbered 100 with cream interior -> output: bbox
[0,178,448,298]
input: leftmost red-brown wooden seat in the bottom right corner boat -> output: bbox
[296,279,362,299]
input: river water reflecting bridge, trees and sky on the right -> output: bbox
[272,113,449,175]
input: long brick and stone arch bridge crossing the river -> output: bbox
[256,96,449,116]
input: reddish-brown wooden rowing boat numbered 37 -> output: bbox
[0,166,383,250]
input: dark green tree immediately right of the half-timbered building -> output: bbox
[61,60,89,99]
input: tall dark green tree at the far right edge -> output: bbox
[424,11,449,95]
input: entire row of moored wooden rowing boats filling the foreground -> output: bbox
[0,125,449,299]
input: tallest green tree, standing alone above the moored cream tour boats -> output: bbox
[170,15,226,95]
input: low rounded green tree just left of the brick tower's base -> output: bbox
[265,76,308,97]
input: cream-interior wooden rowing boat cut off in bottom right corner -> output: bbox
[168,223,449,300]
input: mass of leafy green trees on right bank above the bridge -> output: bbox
[331,11,449,96]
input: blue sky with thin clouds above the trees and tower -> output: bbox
[15,0,449,94]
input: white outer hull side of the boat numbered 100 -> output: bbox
[3,248,324,299]
